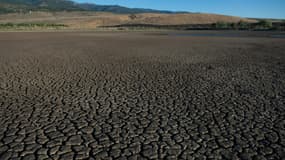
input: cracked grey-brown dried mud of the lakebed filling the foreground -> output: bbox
[0,32,285,160]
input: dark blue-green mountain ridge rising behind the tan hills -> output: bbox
[0,0,180,14]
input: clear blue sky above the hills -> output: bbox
[74,0,285,19]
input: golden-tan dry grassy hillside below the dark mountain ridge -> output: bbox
[0,12,255,29]
